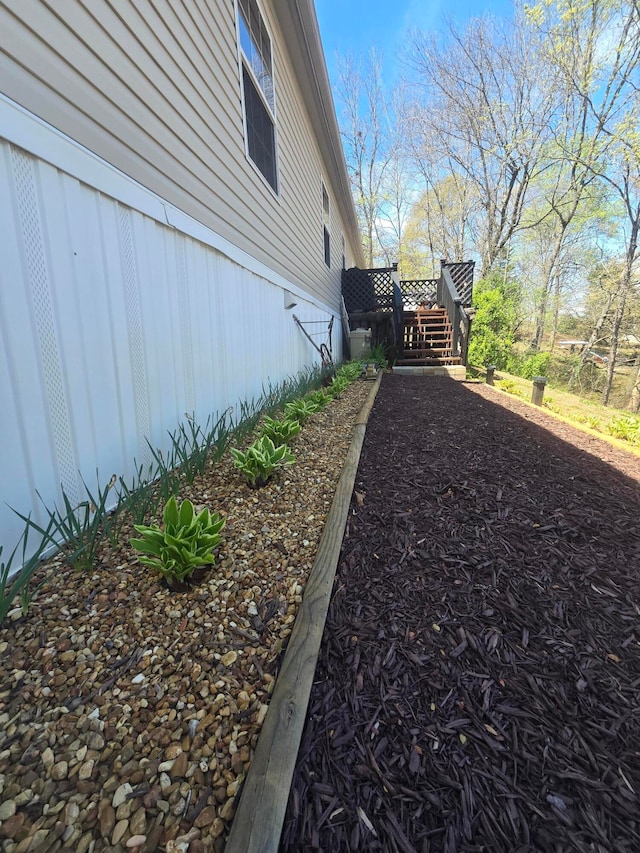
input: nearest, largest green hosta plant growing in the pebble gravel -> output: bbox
[131,497,225,582]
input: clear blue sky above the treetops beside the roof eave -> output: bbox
[315,0,513,85]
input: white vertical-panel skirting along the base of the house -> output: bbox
[0,113,340,549]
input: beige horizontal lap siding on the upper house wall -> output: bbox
[0,0,357,305]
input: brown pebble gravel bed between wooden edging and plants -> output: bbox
[0,382,371,853]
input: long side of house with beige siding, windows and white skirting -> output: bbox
[0,0,362,546]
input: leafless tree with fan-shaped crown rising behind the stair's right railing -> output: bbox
[412,13,558,275]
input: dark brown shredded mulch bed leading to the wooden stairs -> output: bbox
[282,376,640,853]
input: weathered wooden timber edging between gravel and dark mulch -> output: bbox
[225,371,382,853]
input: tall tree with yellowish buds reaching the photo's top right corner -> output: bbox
[527,0,638,349]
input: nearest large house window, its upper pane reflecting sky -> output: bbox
[238,0,278,192]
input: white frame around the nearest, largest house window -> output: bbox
[234,0,280,194]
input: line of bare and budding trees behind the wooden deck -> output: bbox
[336,0,640,411]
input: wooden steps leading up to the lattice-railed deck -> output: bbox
[396,308,461,367]
